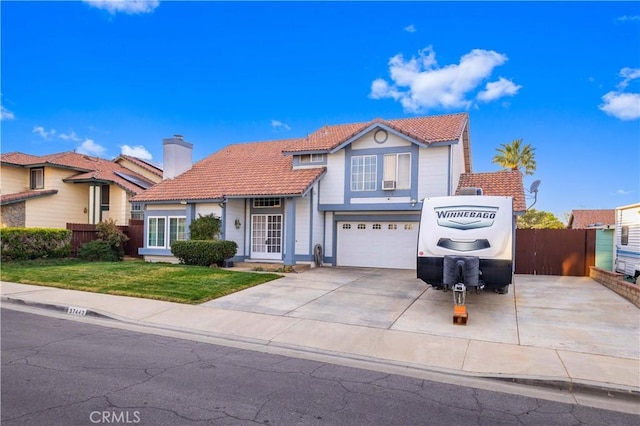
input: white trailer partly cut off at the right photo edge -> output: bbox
[613,203,640,283]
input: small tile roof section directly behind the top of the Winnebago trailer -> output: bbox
[456,170,527,212]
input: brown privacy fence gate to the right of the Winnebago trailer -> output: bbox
[515,229,596,277]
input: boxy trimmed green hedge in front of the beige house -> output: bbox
[0,228,72,260]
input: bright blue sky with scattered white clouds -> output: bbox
[0,1,640,219]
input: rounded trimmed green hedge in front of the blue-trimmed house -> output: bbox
[171,240,238,266]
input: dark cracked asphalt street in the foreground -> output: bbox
[1,309,640,425]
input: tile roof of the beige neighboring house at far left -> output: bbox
[0,151,153,194]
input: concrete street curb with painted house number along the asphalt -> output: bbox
[0,296,640,403]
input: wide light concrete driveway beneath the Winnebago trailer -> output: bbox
[204,268,640,359]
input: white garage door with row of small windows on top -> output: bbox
[336,221,418,269]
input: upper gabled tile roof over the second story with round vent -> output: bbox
[284,113,469,153]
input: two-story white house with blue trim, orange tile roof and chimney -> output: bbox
[133,113,524,268]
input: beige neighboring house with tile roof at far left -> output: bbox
[0,152,162,228]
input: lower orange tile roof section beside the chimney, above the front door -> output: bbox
[132,139,325,201]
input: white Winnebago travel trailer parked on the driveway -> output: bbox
[417,195,515,293]
